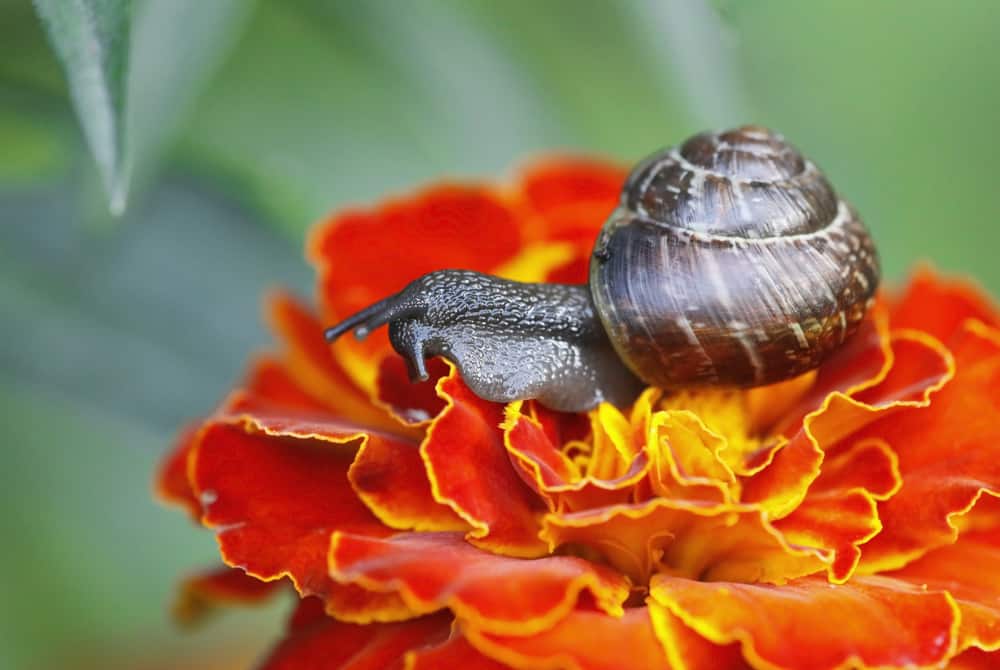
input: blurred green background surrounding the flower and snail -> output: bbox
[0,0,1000,668]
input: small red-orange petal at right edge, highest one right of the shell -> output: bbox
[892,266,1000,343]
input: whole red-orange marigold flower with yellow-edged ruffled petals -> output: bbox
[158,159,1000,670]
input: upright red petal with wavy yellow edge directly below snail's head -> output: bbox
[420,366,545,556]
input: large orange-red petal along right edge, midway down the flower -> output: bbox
[863,322,1000,571]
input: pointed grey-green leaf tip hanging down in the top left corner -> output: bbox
[35,0,132,214]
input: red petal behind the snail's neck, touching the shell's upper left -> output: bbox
[521,158,628,244]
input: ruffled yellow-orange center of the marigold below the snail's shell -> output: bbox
[542,389,816,588]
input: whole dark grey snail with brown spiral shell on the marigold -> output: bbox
[326,126,879,411]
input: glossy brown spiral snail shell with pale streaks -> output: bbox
[590,126,879,388]
